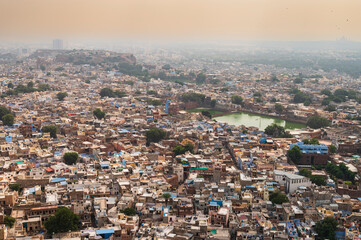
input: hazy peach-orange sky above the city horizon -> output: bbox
[0,0,361,41]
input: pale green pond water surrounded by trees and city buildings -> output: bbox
[214,112,306,131]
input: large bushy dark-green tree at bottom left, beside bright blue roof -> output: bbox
[44,207,80,234]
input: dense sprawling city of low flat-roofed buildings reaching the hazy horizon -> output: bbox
[0,39,361,240]
